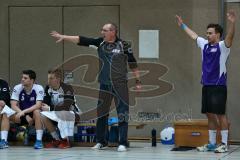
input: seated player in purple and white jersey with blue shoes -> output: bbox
[0,70,44,149]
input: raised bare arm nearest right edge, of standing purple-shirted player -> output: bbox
[224,10,236,47]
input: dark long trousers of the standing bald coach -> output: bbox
[96,82,129,146]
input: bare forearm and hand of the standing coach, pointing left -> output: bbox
[50,31,79,44]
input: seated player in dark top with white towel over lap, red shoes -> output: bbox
[41,69,80,149]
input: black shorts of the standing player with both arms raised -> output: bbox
[202,86,227,114]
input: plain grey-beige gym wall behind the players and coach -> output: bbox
[0,0,240,140]
